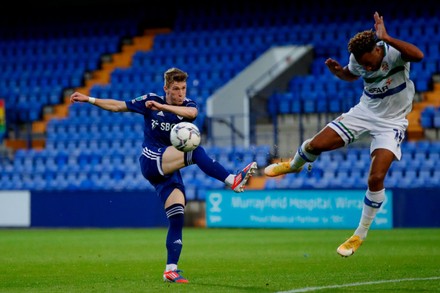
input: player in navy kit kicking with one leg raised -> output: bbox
[70,68,257,283]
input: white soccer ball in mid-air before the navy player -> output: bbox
[170,122,200,152]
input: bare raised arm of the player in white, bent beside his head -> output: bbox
[374,12,424,62]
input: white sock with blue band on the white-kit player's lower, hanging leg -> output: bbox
[354,189,385,240]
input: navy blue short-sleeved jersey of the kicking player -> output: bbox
[125,93,197,148]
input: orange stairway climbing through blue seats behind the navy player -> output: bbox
[5,28,170,150]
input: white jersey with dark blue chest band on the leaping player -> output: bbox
[348,42,415,120]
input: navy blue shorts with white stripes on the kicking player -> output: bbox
[139,147,186,204]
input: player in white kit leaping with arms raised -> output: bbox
[264,12,424,257]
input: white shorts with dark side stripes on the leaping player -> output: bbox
[327,104,408,160]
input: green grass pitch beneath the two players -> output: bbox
[0,228,440,293]
